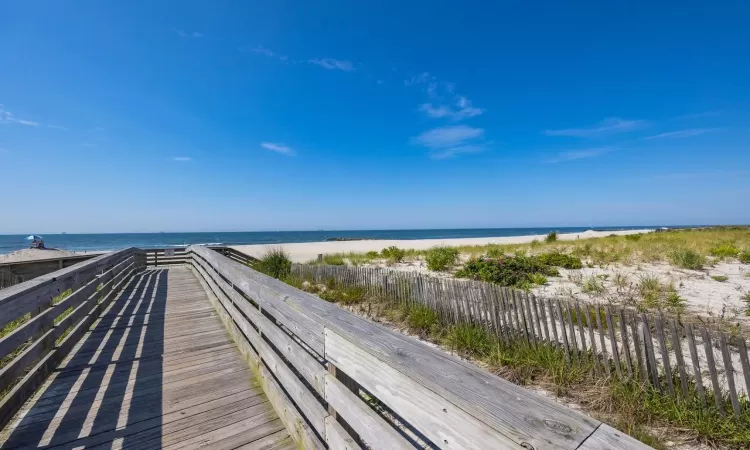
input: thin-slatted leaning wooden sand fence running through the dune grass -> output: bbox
[292,264,750,416]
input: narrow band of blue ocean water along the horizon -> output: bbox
[0,225,660,254]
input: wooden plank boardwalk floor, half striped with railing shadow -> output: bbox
[0,267,295,449]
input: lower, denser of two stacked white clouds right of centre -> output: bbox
[411,125,486,159]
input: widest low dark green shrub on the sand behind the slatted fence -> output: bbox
[456,256,560,288]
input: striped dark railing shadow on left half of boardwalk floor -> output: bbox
[2,270,169,449]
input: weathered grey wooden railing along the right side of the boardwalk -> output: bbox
[187,246,648,449]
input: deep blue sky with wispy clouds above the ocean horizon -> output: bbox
[0,0,750,233]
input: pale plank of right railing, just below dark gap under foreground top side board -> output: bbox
[325,374,413,449]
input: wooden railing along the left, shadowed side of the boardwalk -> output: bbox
[0,248,145,429]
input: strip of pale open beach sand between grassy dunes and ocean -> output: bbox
[233,229,654,262]
